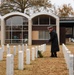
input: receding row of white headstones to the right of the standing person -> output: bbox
[62,44,74,75]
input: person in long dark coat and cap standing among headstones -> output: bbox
[47,26,59,57]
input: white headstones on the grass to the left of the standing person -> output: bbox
[0,44,46,75]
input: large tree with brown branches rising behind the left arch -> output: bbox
[0,0,51,14]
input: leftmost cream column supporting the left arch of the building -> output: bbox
[1,18,5,45]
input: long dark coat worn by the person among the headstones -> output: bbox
[49,30,59,52]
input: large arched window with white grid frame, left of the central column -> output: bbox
[5,16,28,43]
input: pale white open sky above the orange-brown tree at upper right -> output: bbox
[50,0,74,9]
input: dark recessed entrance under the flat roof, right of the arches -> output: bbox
[60,23,74,44]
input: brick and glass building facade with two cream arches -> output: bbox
[0,12,74,45]
